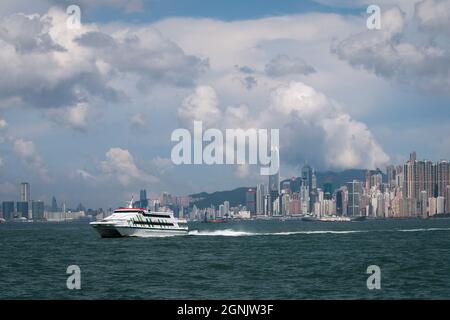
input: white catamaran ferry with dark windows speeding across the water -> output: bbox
[90,202,189,238]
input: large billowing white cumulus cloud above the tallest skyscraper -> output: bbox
[179,81,389,171]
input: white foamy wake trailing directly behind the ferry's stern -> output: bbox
[189,229,367,237]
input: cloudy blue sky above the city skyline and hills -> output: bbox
[0,0,450,208]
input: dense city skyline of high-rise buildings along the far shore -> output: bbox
[2,151,450,221]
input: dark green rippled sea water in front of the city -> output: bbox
[0,219,450,299]
